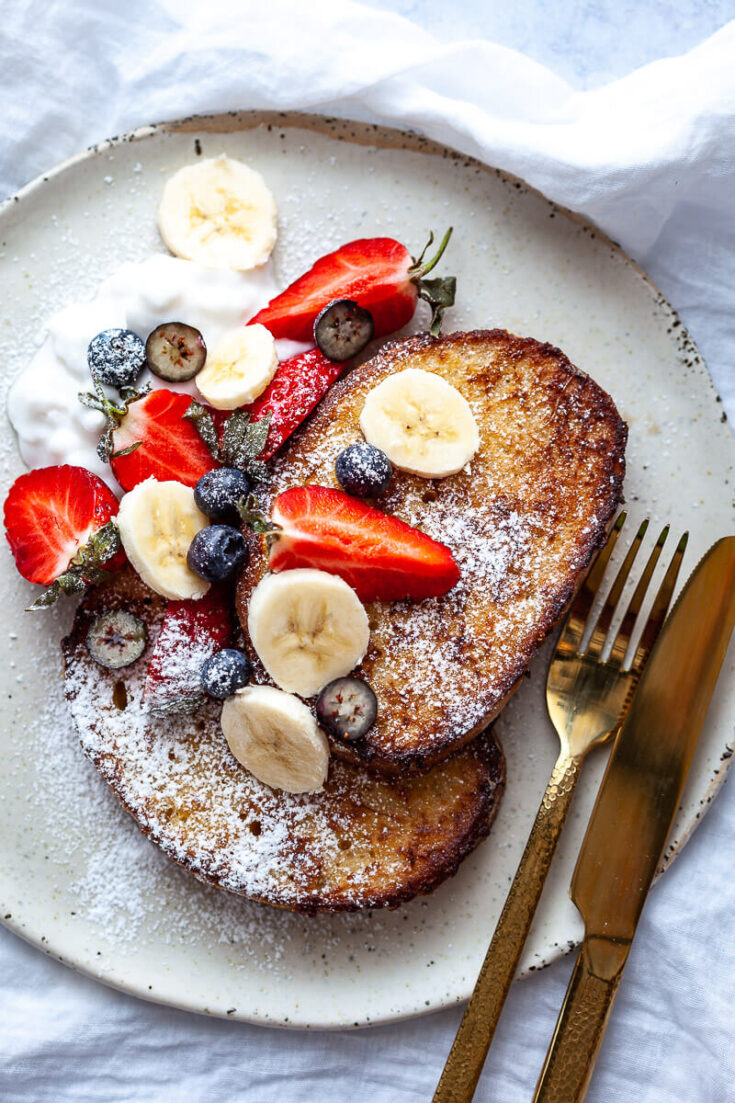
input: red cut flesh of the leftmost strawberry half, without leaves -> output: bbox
[4,464,125,586]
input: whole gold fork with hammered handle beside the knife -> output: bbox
[434,513,688,1103]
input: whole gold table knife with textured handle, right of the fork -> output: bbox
[534,536,735,1103]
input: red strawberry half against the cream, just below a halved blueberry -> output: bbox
[109,387,219,490]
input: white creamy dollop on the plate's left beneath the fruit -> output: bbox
[8,254,311,493]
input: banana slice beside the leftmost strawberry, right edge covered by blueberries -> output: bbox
[117,478,210,600]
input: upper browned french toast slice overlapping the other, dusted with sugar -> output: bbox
[237,330,628,773]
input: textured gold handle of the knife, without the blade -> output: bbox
[533,936,630,1103]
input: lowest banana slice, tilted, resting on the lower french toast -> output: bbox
[222,686,329,793]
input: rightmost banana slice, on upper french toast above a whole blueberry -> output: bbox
[360,367,480,479]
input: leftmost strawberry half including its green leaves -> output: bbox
[4,464,125,609]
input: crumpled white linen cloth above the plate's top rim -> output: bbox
[0,0,735,411]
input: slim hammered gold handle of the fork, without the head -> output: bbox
[433,754,582,1103]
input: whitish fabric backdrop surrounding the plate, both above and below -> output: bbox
[0,0,735,1103]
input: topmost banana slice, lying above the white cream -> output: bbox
[158,153,276,271]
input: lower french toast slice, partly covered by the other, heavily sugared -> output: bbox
[63,568,504,912]
